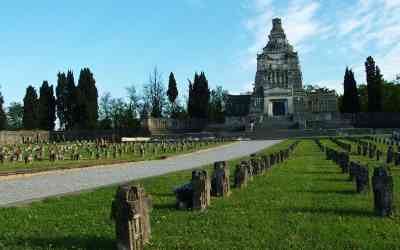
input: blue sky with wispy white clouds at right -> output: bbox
[0,0,400,104]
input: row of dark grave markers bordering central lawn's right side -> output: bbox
[315,140,394,217]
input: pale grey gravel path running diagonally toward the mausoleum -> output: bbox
[0,141,280,206]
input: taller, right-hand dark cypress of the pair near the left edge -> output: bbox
[39,81,56,131]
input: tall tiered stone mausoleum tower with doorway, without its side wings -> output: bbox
[250,18,303,118]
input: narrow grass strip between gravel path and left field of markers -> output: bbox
[0,142,231,174]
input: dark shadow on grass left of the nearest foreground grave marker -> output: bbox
[14,236,116,250]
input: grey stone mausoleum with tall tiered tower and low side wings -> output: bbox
[227,18,338,127]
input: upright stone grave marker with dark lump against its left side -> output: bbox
[192,170,211,210]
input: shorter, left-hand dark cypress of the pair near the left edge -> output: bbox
[22,85,39,129]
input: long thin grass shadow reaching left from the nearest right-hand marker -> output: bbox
[285,207,375,218]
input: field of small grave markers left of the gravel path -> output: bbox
[0,139,225,164]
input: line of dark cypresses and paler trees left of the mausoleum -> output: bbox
[0,68,227,130]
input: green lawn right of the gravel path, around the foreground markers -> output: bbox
[0,140,400,250]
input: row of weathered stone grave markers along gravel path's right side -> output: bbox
[111,142,298,250]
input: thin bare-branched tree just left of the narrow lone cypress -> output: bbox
[143,68,166,118]
